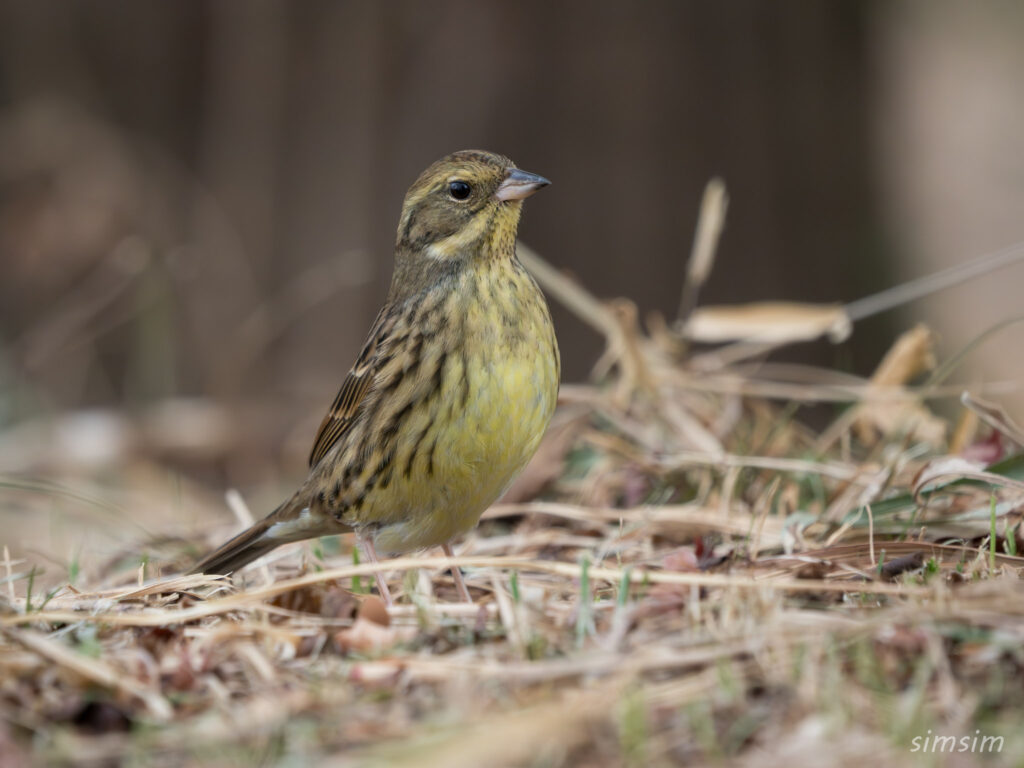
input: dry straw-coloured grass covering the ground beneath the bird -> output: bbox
[0,219,1024,768]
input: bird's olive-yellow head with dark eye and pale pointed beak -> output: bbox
[396,150,551,261]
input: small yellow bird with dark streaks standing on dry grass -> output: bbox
[190,150,560,605]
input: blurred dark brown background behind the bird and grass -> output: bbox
[0,0,1024,565]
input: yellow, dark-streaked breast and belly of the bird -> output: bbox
[367,264,559,552]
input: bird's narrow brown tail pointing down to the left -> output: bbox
[188,496,344,575]
